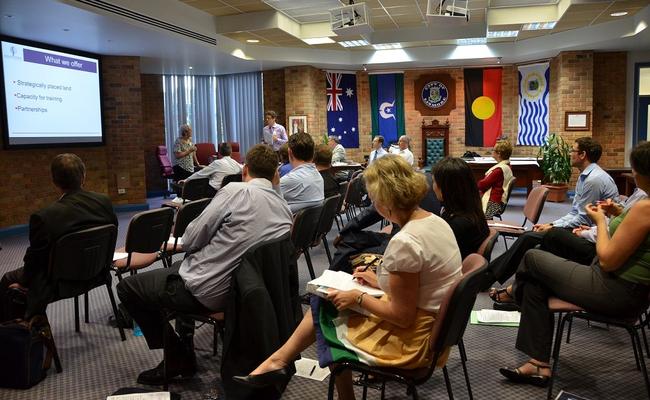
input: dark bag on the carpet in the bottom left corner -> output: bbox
[0,316,54,389]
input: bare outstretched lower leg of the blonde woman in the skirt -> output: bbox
[250,310,316,375]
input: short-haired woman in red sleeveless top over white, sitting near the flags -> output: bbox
[478,140,513,219]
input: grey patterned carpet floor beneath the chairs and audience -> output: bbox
[0,193,647,400]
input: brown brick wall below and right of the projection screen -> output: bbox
[0,57,145,228]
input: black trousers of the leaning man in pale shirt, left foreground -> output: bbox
[117,265,210,357]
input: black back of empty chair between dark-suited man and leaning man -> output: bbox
[124,206,173,253]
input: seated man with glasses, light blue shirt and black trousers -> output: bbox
[490,137,618,286]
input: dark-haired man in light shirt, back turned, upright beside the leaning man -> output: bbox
[280,132,325,214]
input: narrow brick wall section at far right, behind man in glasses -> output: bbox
[592,52,627,168]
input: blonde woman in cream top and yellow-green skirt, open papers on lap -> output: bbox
[235,155,462,399]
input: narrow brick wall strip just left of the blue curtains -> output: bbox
[140,75,167,192]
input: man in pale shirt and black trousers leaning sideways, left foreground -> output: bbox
[117,144,288,385]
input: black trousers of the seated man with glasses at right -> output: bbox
[490,228,596,284]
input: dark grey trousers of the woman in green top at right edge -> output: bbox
[513,249,649,362]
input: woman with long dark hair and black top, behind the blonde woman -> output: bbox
[431,157,490,258]
